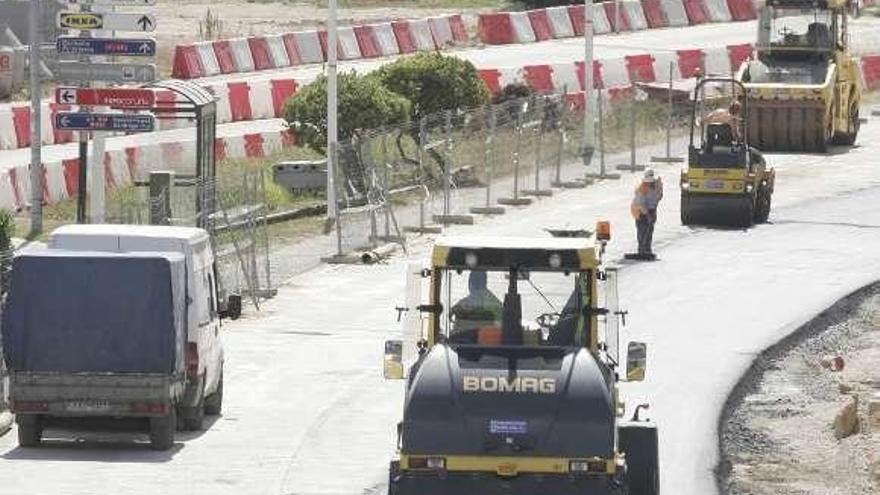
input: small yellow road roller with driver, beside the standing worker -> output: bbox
[680,78,776,227]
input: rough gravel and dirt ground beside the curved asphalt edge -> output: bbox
[719,284,880,495]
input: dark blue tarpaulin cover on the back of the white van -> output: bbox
[3,249,186,373]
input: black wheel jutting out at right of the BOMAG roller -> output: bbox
[618,424,660,495]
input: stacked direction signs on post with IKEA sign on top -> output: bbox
[55,0,157,223]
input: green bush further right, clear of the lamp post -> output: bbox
[368,53,489,120]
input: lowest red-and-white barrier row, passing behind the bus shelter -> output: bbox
[0,130,294,210]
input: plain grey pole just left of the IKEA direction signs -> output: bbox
[29,0,43,236]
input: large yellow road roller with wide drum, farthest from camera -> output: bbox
[737,0,861,152]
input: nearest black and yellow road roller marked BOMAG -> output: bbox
[385,224,659,495]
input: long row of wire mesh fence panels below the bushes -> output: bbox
[326,86,690,260]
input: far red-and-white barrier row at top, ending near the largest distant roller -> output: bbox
[477,0,757,45]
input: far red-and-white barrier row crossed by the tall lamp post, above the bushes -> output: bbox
[172,15,468,79]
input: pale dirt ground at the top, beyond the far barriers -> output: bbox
[144,0,496,73]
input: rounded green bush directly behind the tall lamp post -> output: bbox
[284,72,410,153]
